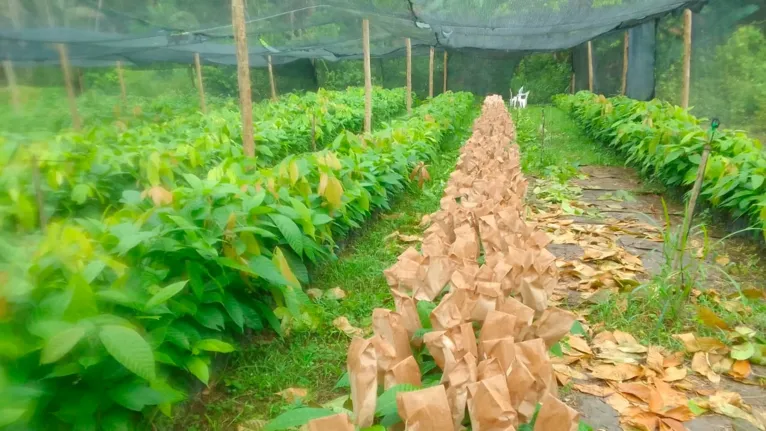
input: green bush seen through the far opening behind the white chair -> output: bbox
[506,53,572,104]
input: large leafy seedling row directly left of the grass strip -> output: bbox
[0,89,473,430]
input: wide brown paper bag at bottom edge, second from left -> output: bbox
[396,385,455,431]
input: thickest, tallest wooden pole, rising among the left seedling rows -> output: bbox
[231,0,255,157]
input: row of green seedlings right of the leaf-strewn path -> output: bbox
[557,91,766,238]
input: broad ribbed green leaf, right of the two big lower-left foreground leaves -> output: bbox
[99,325,155,381]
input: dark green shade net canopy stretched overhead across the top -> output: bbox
[0,0,701,67]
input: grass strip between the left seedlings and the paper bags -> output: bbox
[173,105,470,431]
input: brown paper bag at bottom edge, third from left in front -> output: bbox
[468,375,518,431]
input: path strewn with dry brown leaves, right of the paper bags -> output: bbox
[528,166,766,431]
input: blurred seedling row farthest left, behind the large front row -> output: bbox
[0,88,412,230]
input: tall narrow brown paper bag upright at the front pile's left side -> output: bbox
[346,337,378,428]
